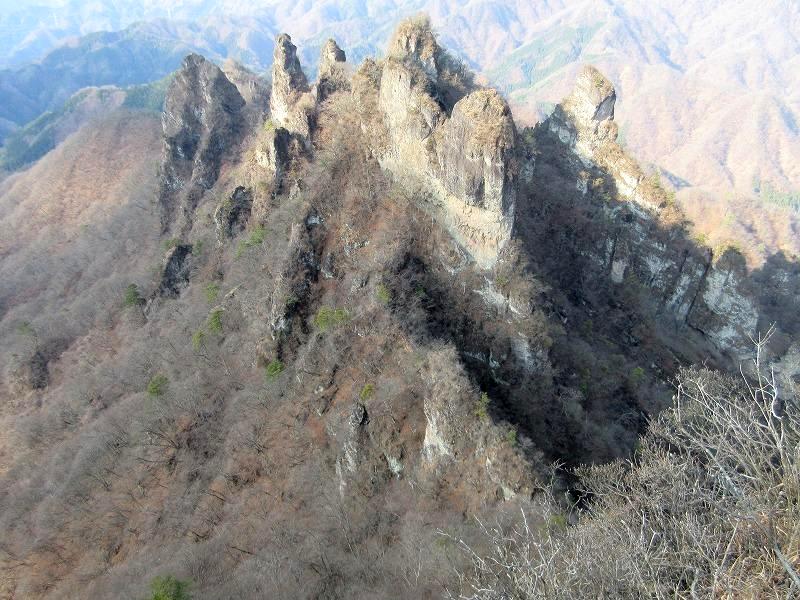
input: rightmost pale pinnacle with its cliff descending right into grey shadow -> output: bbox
[535,67,776,360]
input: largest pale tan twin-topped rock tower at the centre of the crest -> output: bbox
[379,21,516,268]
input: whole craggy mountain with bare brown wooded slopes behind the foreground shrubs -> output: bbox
[0,19,800,598]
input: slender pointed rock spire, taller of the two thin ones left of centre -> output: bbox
[270,33,316,138]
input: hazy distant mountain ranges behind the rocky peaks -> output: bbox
[0,0,800,254]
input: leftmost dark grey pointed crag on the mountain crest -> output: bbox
[159,54,245,232]
